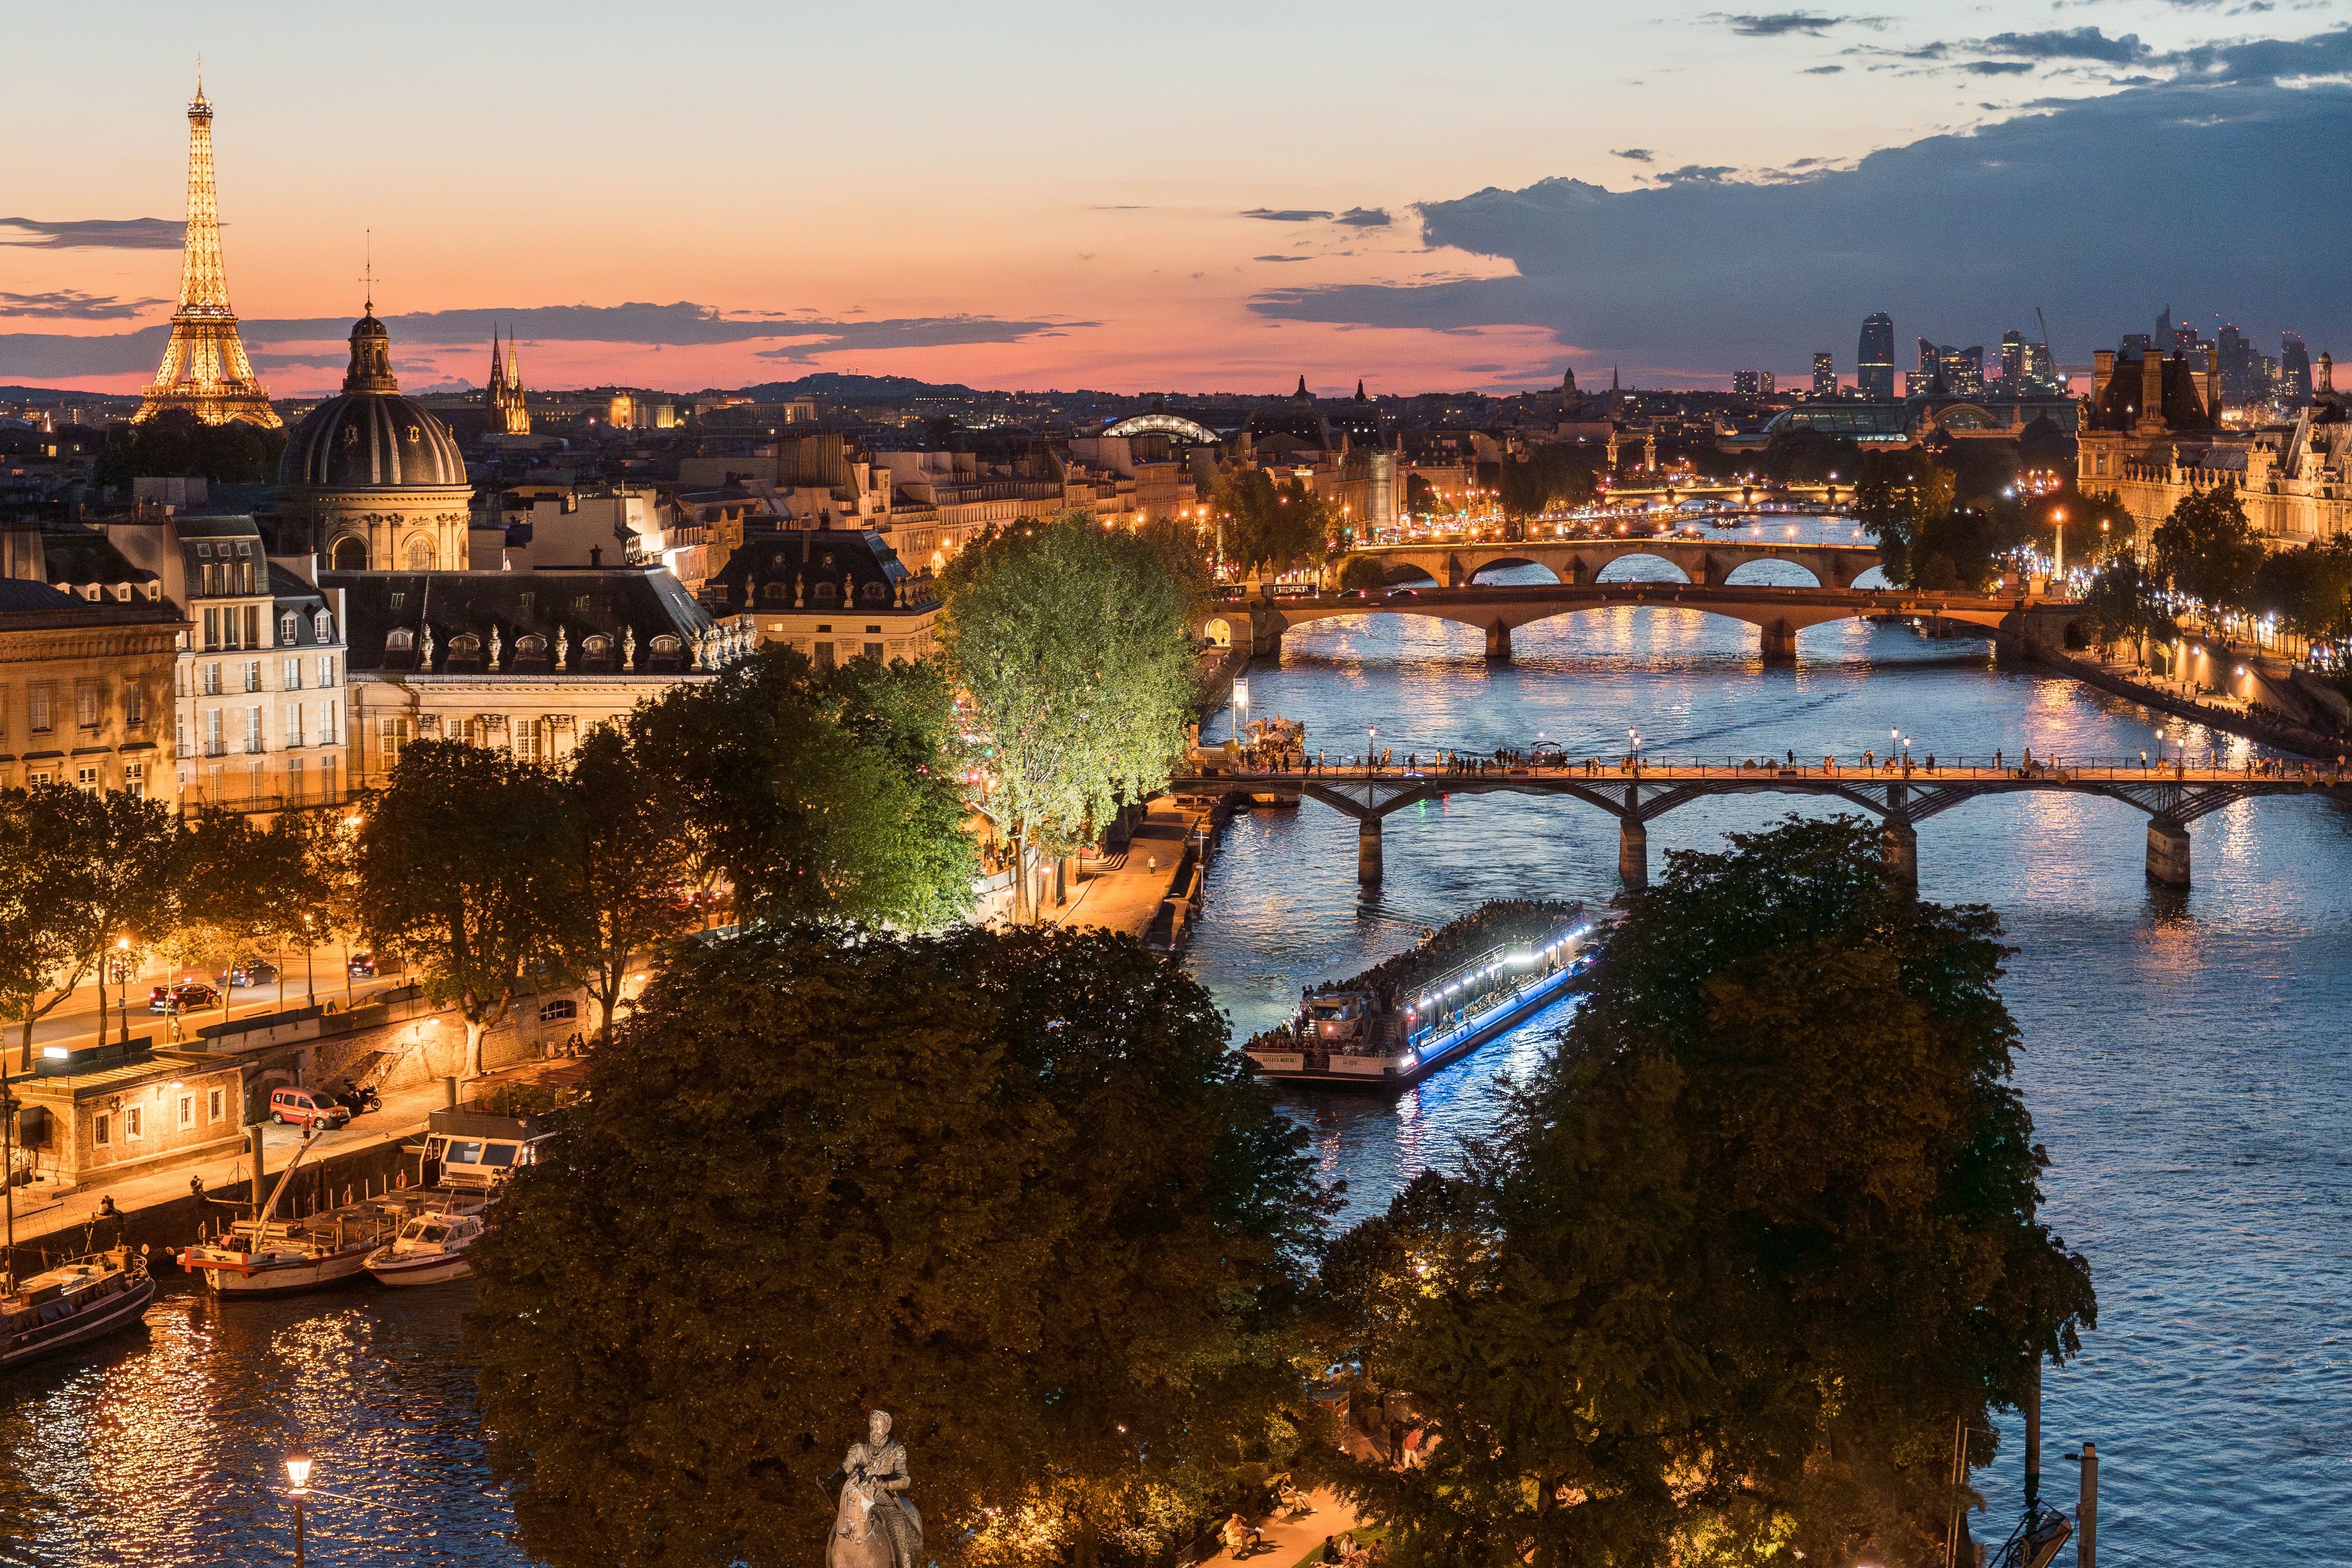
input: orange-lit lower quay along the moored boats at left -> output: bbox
[9,1058,583,1274]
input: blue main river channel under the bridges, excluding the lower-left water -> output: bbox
[1188,550,2352,1563]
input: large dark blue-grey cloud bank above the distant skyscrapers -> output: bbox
[1251,31,2352,369]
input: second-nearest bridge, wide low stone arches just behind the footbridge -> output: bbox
[1192,583,2074,663]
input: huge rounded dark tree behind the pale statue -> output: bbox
[468,926,1329,1568]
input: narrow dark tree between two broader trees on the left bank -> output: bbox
[553,726,694,1044]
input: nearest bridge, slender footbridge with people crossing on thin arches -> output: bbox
[1169,750,2352,889]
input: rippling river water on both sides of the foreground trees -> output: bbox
[0,536,2352,1566]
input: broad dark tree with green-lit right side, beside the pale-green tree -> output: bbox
[630,649,976,926]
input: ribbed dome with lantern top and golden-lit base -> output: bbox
[270,308,473,571]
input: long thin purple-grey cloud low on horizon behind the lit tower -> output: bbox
[0,301,1082,386]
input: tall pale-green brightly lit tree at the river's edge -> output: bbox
[941,512,1192,919]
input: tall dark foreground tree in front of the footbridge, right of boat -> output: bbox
[1322,818,2096,1568]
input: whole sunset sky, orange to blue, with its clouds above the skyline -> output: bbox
[0,0,2352,395]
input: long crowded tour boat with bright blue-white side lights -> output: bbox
[1242,900,1592,1091]
